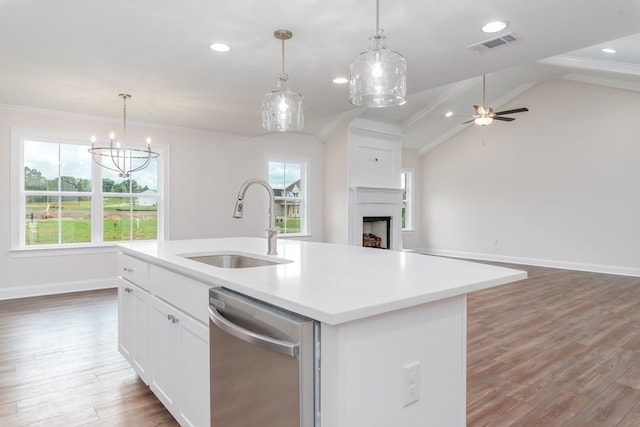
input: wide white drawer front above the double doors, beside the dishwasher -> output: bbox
[149,265,209,325]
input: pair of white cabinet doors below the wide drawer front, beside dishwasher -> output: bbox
[151,298,209,426]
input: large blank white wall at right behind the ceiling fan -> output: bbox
[422,80,640,275]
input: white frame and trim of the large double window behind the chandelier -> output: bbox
[11,127,169,256]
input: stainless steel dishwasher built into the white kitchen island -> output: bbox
[209,288,320,427]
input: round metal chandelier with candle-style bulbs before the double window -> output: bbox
[89,93,159,178]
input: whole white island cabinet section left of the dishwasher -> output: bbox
[118,254,210,427]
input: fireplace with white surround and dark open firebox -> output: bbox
[349,187,402,250]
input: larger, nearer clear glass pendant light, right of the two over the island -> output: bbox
[349,0,407,108]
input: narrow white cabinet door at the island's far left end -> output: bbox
[118,279,150,384]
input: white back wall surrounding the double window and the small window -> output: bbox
[0,106,323,299]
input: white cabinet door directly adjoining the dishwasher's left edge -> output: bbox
[179,316,210,427]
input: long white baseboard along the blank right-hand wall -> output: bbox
[408,248,640,277]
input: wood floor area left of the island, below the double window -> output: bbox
[0,289,178,427]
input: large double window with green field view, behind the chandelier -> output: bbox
[12,131,162,249]
